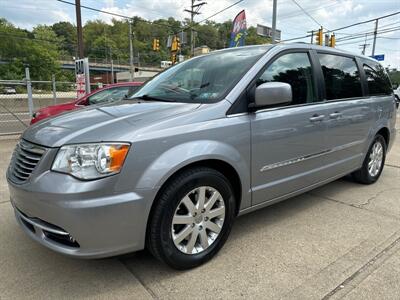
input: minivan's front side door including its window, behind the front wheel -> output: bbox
[250,52,326,205]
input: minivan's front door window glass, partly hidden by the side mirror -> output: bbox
[257,53,316,105]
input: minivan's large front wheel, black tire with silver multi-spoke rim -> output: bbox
[147,167,236,270]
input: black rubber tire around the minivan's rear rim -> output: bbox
[352,134,387,184]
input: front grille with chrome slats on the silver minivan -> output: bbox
[10,140,46,183]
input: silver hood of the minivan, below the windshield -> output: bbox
[22,101,200,147]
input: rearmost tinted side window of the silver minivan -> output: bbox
[363,61,392,95]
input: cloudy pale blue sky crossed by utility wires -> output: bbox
[0,0,400,68]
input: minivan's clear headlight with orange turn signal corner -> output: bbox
[51,143,129,179]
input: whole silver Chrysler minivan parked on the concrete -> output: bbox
[7,44,396,269]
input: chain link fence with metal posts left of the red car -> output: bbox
[0,70,76,135]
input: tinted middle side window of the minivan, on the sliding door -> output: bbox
[319,54,362,100]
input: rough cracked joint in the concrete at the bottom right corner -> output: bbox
[322,237,400,300]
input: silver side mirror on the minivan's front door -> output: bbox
[254,82,292,107]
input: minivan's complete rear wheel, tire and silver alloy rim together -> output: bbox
[353,134,387,184]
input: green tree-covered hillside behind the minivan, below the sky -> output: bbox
[0,17,269,80]
